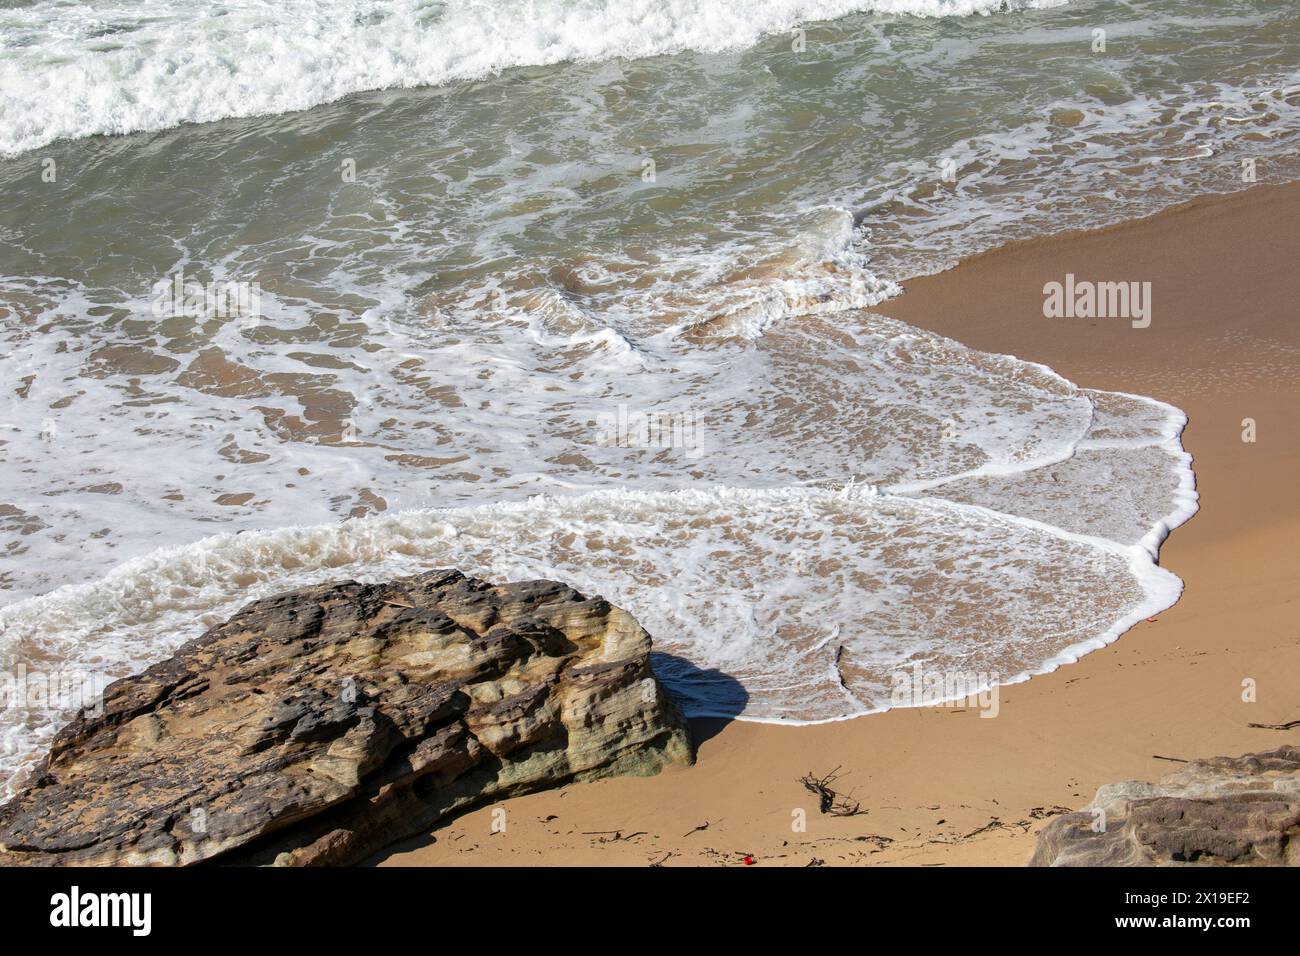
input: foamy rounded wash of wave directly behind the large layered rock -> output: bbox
[0,444,1180,750]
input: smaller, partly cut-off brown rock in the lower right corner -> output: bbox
[1030,747,1300,866]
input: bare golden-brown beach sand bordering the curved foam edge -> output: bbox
[382,185,1300,866]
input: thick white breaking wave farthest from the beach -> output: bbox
[0,0,1065,153]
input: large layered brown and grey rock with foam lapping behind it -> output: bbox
[0,571,690,865]
